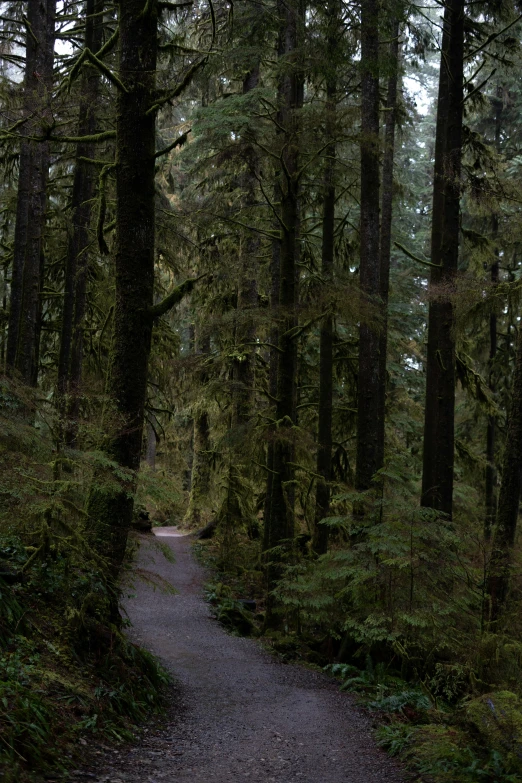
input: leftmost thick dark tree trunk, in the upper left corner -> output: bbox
[6,0,56,384]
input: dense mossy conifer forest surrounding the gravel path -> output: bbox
[0,0,522,783]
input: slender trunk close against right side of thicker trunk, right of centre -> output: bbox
[378,17,399,484]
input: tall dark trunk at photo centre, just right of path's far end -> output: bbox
[265,0,303,608]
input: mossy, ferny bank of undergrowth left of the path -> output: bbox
[0,380,168,783]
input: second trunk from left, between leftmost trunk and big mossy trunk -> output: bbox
[56,0,104,445]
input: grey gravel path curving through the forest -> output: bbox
[87,528,403,783]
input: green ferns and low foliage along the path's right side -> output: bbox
[196,529,522,783]
